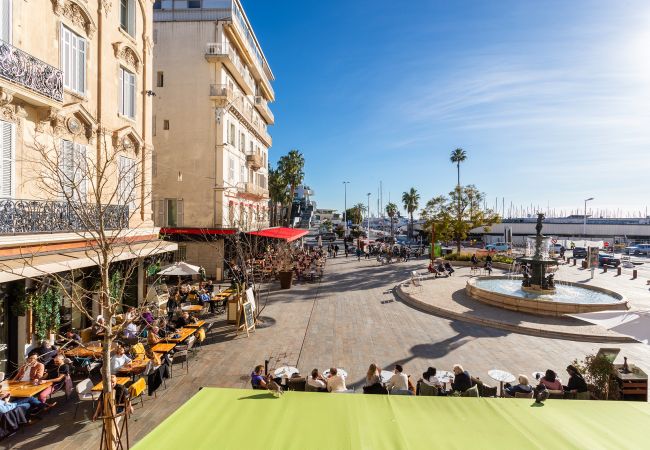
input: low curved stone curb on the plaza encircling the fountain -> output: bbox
[395,279,637,344]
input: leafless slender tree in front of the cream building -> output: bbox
[5,127,168,449]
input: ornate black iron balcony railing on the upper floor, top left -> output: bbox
[0,40,63,102]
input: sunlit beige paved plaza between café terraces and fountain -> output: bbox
[5,257,650,449]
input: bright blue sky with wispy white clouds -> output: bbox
[242,0,650,216]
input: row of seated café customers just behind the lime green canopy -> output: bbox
[251,363,588,401]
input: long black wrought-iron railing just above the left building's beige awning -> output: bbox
[0,199,129,235]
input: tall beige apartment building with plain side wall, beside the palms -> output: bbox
[153,0,275,279]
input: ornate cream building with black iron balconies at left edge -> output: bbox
[0,0,176,373]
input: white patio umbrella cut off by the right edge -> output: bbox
[567,310,650,345]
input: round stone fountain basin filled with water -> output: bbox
[465,276,629,316]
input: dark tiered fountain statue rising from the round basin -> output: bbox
[517,213,558,293]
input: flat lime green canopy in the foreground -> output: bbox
[135,388,650,450]
